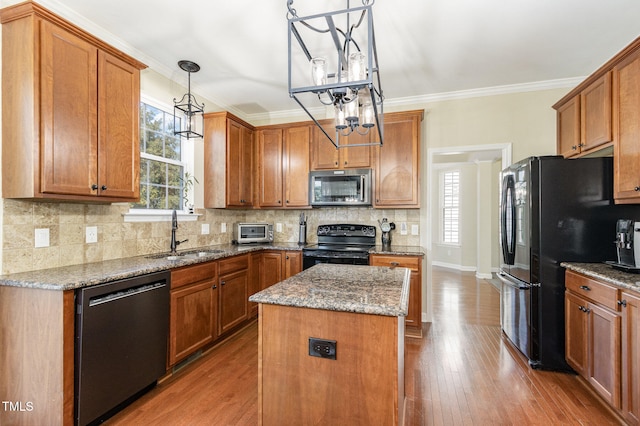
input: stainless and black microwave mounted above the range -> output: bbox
[309,169,372,207]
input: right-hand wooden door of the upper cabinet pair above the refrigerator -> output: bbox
[580,72,613,151]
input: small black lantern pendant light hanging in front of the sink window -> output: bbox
[173,61,204,139]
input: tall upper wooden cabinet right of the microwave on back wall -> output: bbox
[374,111,424,208]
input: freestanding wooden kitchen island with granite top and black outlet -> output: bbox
[249,264,410,425]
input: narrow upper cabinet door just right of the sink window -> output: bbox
[227,120,253,207]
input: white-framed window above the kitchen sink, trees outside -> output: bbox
[131,102,185,210]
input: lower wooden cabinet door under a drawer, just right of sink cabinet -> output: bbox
[218,269,249,334]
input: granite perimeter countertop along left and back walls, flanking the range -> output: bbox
[0,242,423,290]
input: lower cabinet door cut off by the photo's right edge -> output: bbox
[621,292,640,424]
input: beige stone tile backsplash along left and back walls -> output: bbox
[2,199,420,274]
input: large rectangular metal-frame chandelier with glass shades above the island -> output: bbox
[287,0,384,148]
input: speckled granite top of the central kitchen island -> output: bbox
[249,263,410,316]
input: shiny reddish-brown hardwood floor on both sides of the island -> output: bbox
[106,267,619,425]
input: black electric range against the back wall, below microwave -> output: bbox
[302,224,376,269]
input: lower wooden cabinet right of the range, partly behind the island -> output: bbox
[369,254,422,337]
